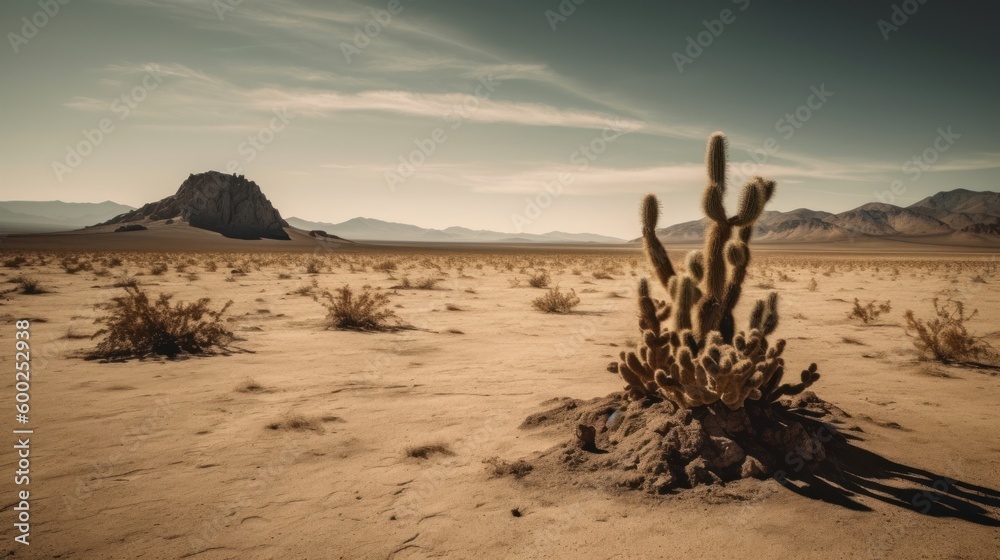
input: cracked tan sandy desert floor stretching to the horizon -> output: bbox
[0,248,1000,560]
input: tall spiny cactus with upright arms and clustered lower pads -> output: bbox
[612,132,819,410]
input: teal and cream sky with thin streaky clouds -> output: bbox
[0,0,1000,238]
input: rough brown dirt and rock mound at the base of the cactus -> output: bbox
[521,392,849,494]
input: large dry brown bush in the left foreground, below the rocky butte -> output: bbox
[88,287,233,360]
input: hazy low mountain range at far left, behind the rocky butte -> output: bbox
[0,200,133,233]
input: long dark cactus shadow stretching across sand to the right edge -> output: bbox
[779,418,1000,527]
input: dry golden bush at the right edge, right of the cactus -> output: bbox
[904,298,997,363]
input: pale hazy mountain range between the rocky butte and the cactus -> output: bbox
[288,218,624,243]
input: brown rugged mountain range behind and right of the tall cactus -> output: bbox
[634,189,1000,243]
